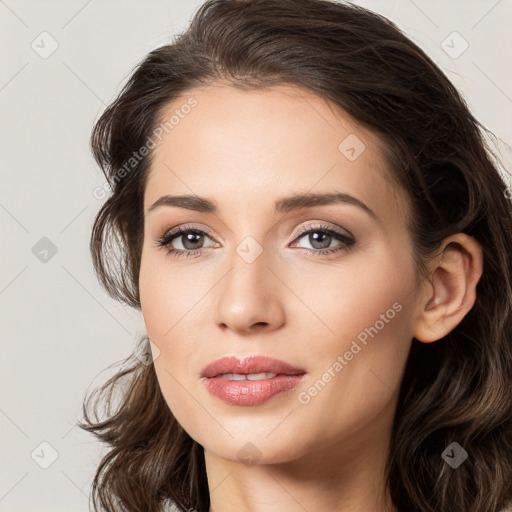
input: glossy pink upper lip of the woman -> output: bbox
[201,356,306,377]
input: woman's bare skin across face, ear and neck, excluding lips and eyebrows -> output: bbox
[139,83,482,512]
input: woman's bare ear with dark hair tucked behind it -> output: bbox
[413,233,483,343]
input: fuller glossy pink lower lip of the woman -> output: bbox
[205,374,305,405]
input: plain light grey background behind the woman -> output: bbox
[0,0,512,512]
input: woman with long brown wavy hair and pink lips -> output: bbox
[81,0,512,512]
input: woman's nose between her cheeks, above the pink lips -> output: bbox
[215,245,285,335]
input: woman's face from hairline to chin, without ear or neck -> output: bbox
[140,84,419,463]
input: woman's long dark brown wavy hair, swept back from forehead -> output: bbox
[79,0,512,512]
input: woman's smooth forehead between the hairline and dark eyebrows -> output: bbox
[144,83,403,225]
